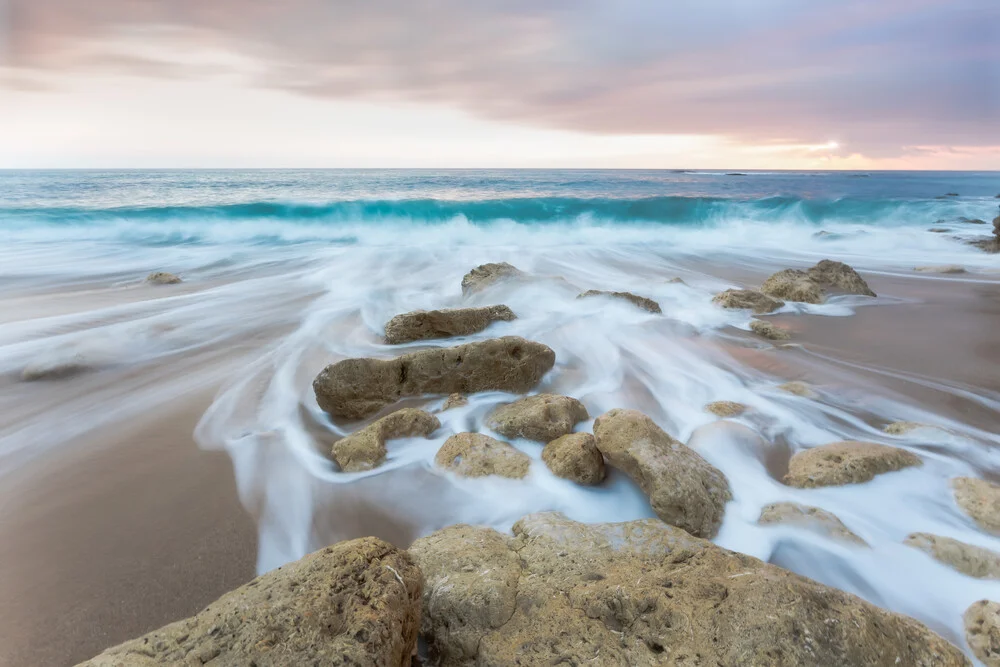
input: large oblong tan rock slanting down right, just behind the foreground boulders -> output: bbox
[594,409,733,538]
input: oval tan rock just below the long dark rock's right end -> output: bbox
[486,394,590,443]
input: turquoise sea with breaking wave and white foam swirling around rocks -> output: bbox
[0,168,1000,664]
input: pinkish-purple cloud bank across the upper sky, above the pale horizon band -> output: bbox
[5,0,1000,157]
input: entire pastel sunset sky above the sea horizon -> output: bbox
[0,0,1000,170]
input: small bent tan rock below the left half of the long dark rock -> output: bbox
[333,408,441,472]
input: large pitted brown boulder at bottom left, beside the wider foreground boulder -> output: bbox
[83,537,422,667]
